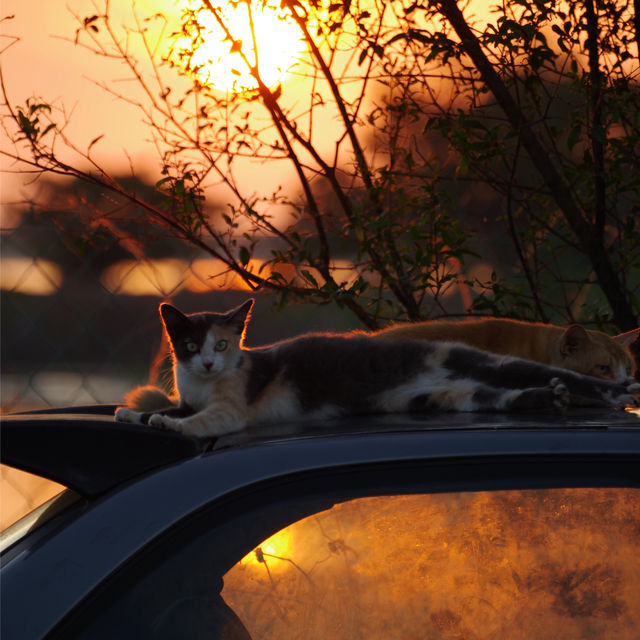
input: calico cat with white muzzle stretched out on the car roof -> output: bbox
[115,300,640,437]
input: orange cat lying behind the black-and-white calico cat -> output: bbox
[374,318,640,382]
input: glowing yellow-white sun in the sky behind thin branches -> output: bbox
[174,0,305,93]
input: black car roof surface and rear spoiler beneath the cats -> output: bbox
[0,405,640,497]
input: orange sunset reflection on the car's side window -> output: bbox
[222,488,640,640]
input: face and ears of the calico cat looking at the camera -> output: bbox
[160,300,253,379]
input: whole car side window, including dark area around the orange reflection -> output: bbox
[54,462,640,640]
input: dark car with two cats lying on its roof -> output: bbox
[0,407,640,639]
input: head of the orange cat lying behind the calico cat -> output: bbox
[557,324,640,382]
